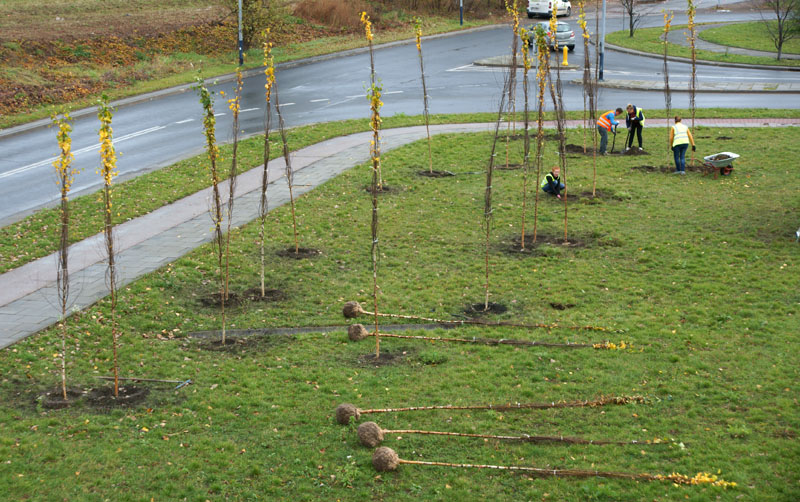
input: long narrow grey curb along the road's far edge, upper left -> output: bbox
[0,24,507,138]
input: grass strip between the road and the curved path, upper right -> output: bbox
[606,25,800,66]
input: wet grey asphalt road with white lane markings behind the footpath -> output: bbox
[0,5,800,225]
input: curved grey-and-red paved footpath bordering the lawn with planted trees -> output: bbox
[0,119,800,349]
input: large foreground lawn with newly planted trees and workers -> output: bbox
[0,123,800,501]
